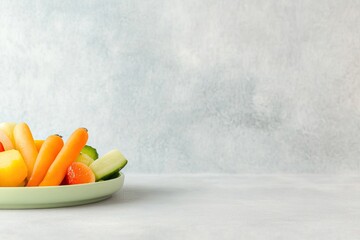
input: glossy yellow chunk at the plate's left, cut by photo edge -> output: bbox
[0,150,28,187]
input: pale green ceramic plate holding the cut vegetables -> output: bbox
[0,173,125,209]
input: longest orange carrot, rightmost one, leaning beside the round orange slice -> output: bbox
[39,128,88,186]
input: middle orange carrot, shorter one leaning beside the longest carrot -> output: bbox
[27,135,64,187]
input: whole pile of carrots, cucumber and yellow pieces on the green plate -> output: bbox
[0,122,127,187]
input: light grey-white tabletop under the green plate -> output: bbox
[0,174,360,240]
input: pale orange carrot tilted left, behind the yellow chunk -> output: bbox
[14,123,38,179]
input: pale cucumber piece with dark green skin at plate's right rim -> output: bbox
[90,149,127,180]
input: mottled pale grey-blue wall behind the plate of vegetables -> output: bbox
[0,0,360,174]
